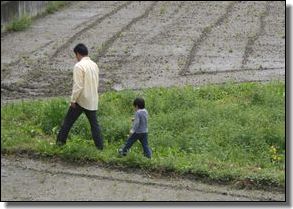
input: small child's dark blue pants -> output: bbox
[123,133,152,158]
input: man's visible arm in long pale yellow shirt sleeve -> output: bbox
[71,66,84,104]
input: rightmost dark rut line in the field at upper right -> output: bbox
[240,2,269,69]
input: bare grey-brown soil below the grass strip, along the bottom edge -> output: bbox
[1,156,285,201]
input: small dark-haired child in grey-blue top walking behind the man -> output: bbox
[118,98,152,158]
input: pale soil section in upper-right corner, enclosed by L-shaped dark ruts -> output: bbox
[184,2,285,77]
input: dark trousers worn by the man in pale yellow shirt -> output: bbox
[56,103,103,150]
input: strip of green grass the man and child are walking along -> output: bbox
[1,82,285,188]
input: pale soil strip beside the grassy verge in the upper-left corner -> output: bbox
[1,1,119,64]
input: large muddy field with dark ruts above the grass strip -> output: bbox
[1,1,285,101]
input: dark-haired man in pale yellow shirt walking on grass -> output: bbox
[56,44,103,150]
